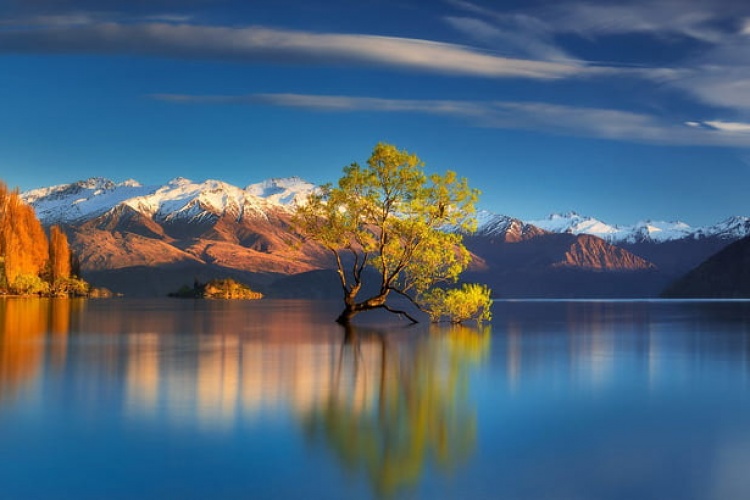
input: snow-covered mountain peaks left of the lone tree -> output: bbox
[22,177,315,224]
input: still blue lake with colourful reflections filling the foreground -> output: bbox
[0,298,750,500]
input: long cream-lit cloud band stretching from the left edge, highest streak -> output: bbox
[0,22,600,79]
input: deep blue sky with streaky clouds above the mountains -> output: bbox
[0,0,750,225]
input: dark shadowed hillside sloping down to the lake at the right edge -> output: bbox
[663,237,750,298]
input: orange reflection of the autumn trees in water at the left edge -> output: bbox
[0,298,83,401]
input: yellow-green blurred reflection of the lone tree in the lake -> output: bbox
[305,326,490,496]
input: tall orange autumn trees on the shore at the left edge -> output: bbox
[0,181,88,296]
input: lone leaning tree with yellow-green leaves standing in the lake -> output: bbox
[294,143,490,324]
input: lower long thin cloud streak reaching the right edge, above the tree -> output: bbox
[151,94,750,148]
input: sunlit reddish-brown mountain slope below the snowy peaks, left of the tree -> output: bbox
[69,206,330,296]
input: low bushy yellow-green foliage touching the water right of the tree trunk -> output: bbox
[422,283,492,323]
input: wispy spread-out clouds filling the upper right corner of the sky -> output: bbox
[445,0,750,117]
